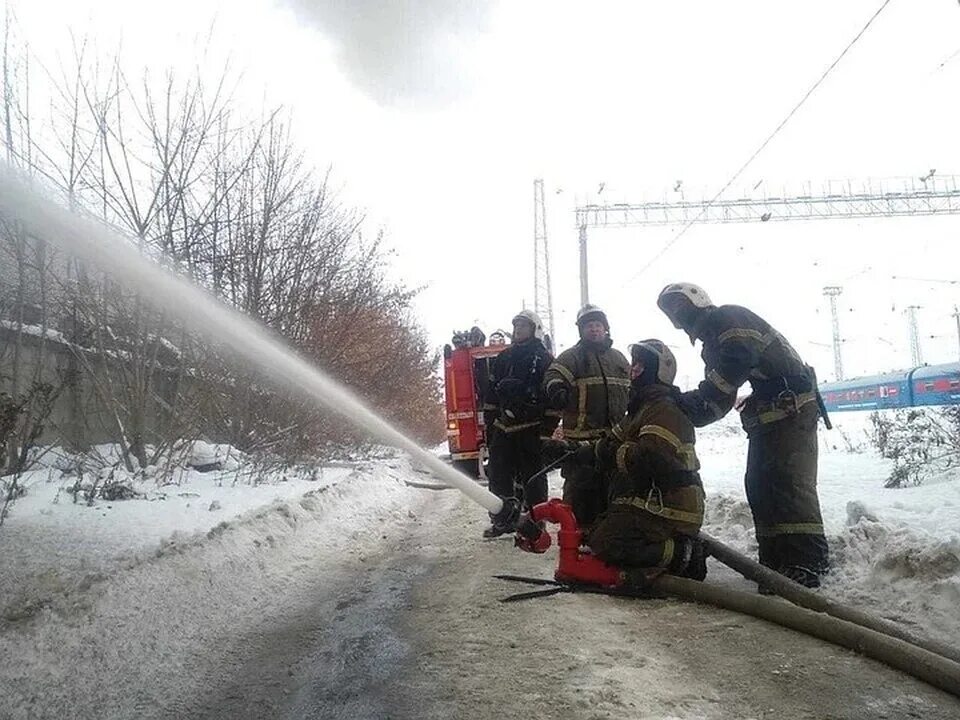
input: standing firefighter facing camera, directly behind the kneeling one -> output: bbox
[544,305,630,532]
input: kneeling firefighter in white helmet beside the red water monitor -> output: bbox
[548,340,706,580]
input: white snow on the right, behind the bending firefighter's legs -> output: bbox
[697,413,960,643]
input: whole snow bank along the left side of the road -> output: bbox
[0,452,423,718]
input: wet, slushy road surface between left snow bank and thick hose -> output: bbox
[184,492,960,720]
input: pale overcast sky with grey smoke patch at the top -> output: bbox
[13,0,960,386]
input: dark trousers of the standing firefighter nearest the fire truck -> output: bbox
[487,427,547,507]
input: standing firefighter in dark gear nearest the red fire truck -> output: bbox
[483,310,557,538]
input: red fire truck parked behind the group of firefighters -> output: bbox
[443,328,507,477]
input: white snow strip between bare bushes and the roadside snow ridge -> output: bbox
[0,443,364,619]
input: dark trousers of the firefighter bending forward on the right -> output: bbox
[746,403,829,573]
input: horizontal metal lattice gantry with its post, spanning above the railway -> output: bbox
[576,178,960,304]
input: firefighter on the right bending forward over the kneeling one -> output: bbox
[657,283,829,587]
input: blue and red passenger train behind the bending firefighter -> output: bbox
[820,363,960,412]
